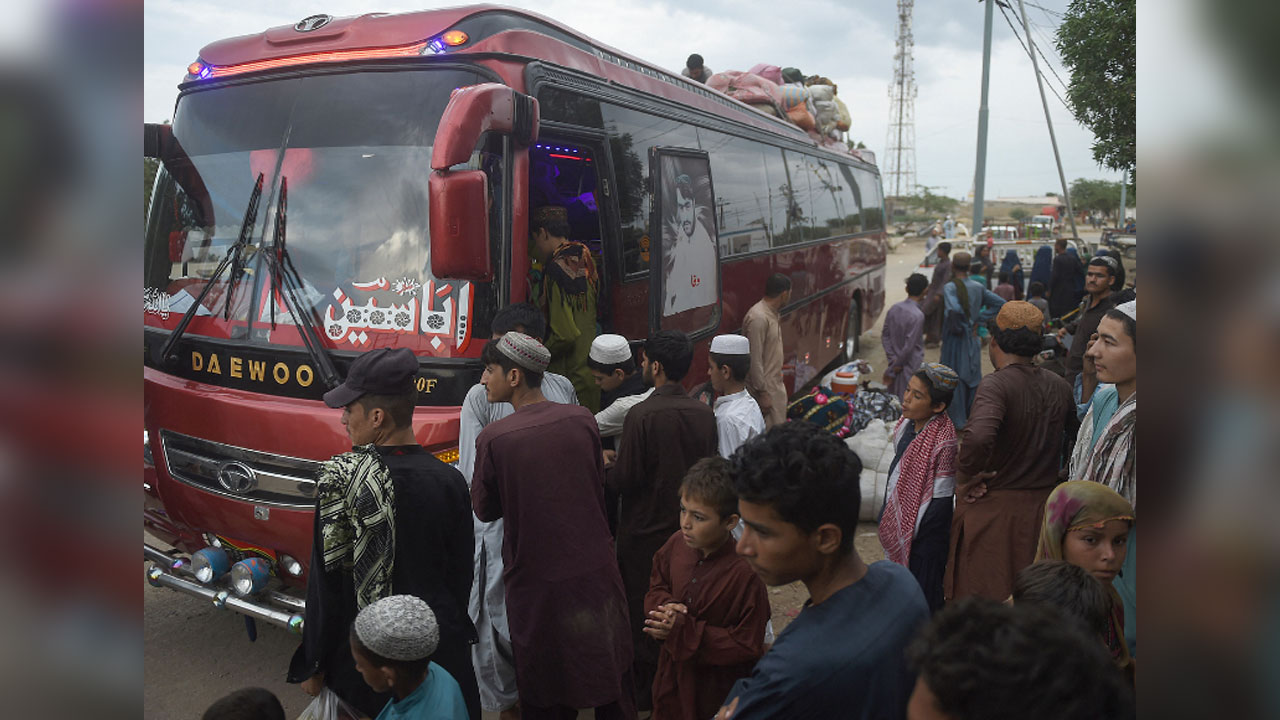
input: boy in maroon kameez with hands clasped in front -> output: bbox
[644,457,771,720]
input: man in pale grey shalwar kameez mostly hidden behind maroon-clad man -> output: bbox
[458,302,577,720]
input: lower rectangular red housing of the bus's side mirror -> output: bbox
[428,170,493,282]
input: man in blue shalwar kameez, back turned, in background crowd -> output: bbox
[941,252,1005,428]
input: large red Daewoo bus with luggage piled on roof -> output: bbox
[143,6,886,629]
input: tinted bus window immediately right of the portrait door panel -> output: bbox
[698,129,769,258]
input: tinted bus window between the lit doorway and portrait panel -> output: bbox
[600,102,700,275]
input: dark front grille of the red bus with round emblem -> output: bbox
[160,430,320,509]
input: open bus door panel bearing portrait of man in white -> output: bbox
[649,147,721,341]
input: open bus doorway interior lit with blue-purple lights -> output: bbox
[529,132,618,328]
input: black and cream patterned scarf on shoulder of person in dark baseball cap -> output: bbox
[316,445,396,609]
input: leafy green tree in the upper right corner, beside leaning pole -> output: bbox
[1055,0,1138,170]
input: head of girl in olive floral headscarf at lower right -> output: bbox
[1036,480,1134,670]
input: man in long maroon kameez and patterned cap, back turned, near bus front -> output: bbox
[471,332,635,720]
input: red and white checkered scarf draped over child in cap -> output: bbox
[879,413,956,565]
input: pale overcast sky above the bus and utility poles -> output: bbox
[143,0,1119,199]
